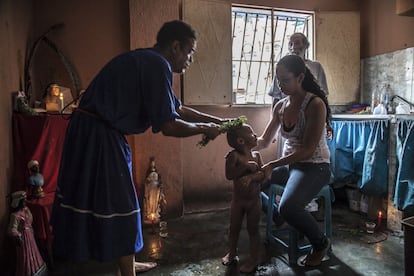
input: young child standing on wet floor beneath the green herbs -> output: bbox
[222,124,264,273]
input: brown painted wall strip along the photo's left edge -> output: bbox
[0,0,33,266]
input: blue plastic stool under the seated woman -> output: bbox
[262,184,335,264]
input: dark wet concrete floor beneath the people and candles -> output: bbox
[50,196,404,276]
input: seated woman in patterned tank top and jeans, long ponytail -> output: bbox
[256,55,331,266]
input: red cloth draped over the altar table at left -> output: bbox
[11,113,69,260]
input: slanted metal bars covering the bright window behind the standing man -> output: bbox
[232,6,313,104]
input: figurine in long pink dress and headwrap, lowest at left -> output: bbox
[7,191,47,276]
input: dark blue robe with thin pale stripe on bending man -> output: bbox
[51,49,181,261]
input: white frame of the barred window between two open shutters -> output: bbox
[231,4,315,106]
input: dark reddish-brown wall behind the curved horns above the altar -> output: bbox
[31,0,129,102]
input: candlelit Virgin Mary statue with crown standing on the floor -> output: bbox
[144,158,164,224]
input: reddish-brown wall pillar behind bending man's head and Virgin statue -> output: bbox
[128,0,183,217]
